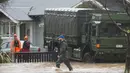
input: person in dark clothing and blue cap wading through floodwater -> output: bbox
[56,35,73,71]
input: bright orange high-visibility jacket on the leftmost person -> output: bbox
[10,40,21,53]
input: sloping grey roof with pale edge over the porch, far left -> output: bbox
[0,7,32,23]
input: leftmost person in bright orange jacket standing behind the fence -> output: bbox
[10,34,21,53]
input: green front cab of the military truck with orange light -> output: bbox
[78,13,130,62]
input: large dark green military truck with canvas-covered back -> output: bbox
[44,8,130,62]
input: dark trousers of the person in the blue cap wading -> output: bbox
[56,56,73,70]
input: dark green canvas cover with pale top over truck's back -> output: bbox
[45,8,93,45]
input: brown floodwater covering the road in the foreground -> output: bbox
[0,62,125,73]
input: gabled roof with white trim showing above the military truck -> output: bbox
[73,0,125,11]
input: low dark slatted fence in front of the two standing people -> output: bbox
[14,52,57,63]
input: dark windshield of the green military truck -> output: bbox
[99,23,130,37]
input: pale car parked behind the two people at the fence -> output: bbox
[0,40,40,53]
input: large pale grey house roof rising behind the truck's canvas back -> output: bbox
[9,0,81,15]
